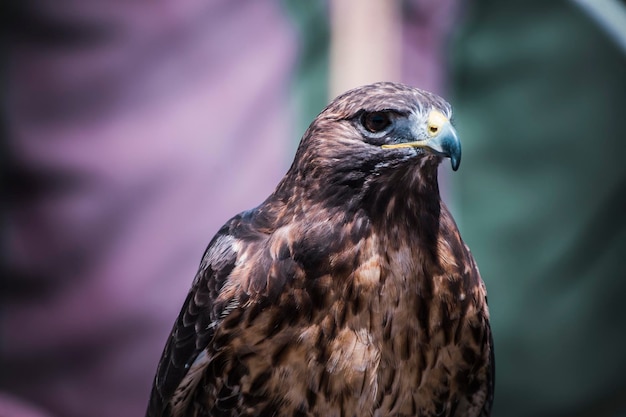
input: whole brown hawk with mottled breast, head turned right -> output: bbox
[147,82,494,417]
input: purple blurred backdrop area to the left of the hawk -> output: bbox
[0,0,296,417]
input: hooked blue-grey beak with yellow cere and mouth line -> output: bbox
[382,110,461,171]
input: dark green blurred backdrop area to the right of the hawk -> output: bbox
[450,1,626,417]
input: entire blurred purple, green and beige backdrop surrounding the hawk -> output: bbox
[0,0,626,417]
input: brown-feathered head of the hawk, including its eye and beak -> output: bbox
[295,82,461,180]
